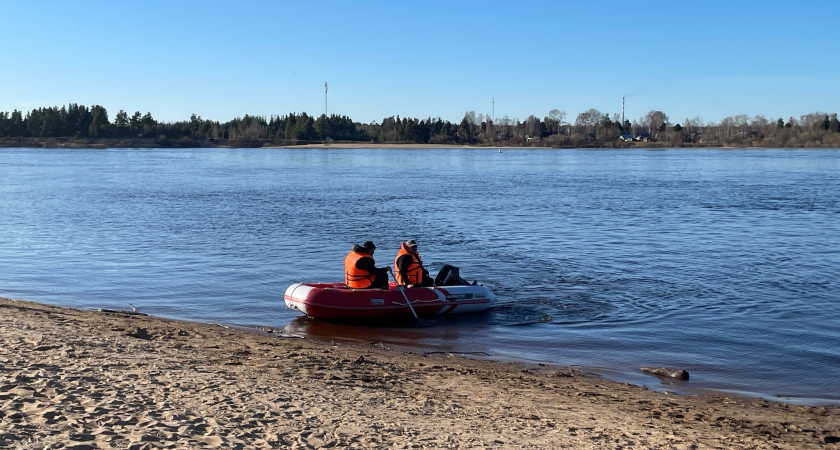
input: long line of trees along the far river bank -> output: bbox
[0,103,840,147]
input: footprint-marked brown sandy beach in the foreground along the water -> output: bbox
[0,299,840,449]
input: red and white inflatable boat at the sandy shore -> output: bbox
[283,283,496,320]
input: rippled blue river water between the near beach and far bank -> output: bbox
[0,149,840,403]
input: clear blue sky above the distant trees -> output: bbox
[0,0,840,123]
